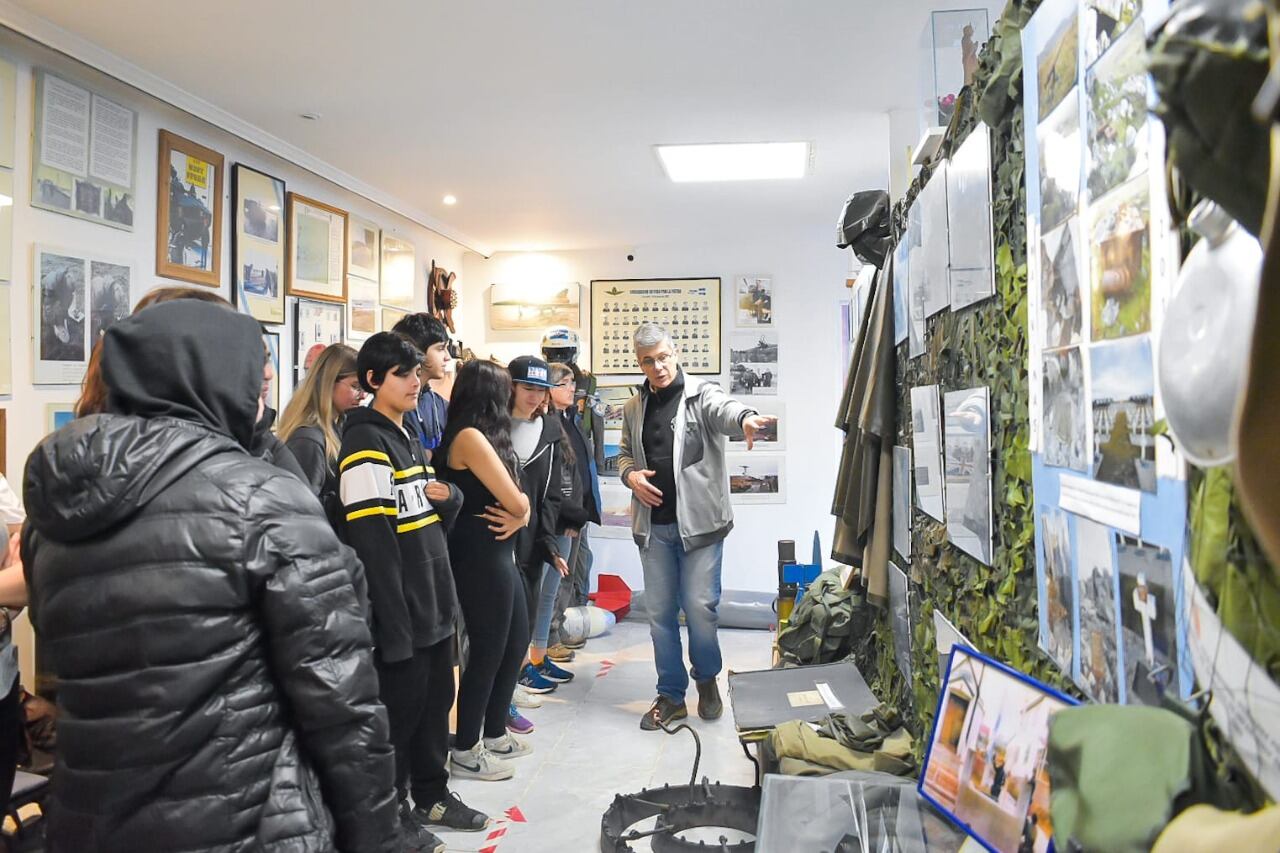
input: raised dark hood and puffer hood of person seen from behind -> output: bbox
[23,300,262,542]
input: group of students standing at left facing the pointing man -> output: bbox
[13,288,599,852]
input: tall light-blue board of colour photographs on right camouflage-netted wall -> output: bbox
[1023,0,1192,703]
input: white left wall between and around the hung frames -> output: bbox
[0,29,463,685]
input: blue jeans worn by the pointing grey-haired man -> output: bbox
[640,524,724,702]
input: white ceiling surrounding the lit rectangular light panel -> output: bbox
[2,0,1001,250]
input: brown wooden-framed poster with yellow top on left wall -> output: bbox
[156,131,223,287]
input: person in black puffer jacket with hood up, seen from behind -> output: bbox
[22,301,403,853]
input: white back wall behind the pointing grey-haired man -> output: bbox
[458,233,850,592]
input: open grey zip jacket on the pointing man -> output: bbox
[618,374,758,551]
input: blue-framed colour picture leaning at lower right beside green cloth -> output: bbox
[919,646,1076,853]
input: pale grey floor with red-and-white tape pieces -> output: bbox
[440,621,772,853]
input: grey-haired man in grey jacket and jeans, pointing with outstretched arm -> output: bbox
[618,323,776,731]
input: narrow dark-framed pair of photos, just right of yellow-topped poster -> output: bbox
[232,163,284,325]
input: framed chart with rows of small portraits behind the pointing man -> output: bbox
[591,278,721,377]
